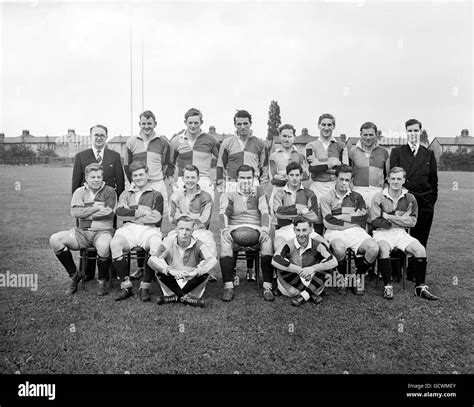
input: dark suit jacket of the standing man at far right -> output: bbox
[390,144,438,209]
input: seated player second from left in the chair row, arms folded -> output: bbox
[110,161,163,302]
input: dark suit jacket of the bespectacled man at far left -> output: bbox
[72,147,125,196]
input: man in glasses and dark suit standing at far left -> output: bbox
[72,124,125,281]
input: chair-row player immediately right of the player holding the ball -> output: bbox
[273,162,318,253]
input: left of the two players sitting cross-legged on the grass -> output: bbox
[148,215,217,307]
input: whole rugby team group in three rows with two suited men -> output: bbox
[50,108,438,307]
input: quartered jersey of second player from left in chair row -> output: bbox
[117,184,163,228]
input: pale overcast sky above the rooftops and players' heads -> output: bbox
[0,0,474,140]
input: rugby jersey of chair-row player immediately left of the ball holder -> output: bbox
[169,185,213,229]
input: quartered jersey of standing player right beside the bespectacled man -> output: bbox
[124,132,174,183]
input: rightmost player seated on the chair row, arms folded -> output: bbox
[372,167,438,300]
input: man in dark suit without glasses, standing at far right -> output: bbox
[390,119,438,279]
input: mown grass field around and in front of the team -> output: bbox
[0,167,474,374]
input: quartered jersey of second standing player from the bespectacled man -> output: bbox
[171,132,219,177]
